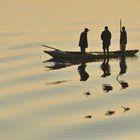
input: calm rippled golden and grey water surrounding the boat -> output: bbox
[0,0,140,140]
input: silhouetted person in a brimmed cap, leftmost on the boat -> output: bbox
[79,28,89,54]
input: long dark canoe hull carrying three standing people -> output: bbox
[44,50,139,60]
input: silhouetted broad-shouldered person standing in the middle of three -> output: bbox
[101,26,111,55]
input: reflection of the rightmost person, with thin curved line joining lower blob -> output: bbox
[117,55,129,89]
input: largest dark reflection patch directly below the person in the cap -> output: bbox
[78,62,89,81]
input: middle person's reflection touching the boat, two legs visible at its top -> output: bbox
[101,58,111,77]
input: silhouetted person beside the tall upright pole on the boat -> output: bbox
[120,26,127,53]
